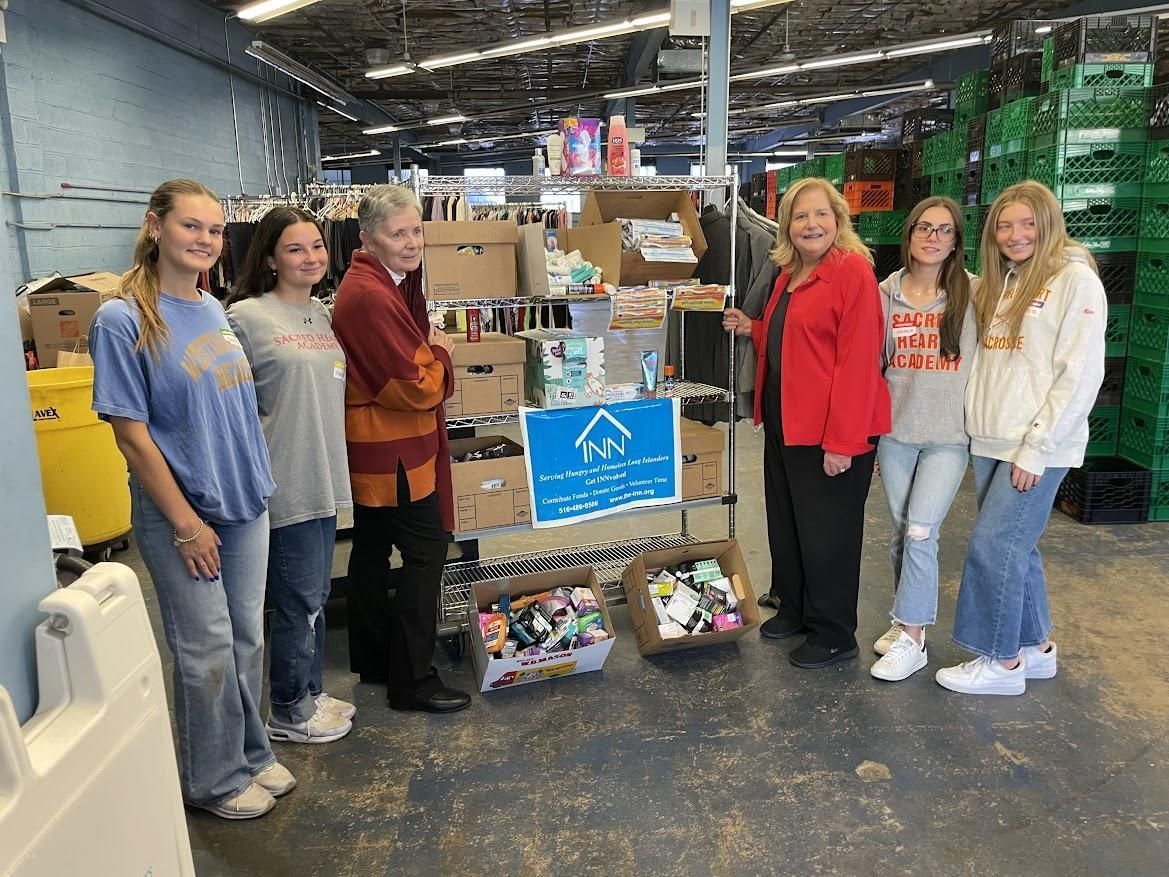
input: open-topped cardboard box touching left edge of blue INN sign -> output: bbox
[450,435,532,533]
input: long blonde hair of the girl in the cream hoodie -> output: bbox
[974,180,1097,336]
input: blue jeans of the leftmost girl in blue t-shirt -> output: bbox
[130,478,276,805]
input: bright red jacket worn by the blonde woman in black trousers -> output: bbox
[752,249,892,457]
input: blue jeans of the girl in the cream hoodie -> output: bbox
[954,457,1067,661]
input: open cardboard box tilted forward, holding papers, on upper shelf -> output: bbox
[570,191,706,286]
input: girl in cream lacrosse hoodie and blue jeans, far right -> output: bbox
[935,180,1107,695]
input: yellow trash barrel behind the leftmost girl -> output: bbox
[27,366,130,547]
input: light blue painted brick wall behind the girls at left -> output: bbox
[0,0,317,277]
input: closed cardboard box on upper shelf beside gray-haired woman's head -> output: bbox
[422,221,517,301]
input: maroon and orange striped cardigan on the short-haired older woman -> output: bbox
[333,250,455,531]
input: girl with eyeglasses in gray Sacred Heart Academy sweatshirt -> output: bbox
[870,198,977,682]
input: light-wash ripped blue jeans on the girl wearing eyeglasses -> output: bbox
[877,435,970,627]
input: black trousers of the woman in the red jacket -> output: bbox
[763,384,877,649]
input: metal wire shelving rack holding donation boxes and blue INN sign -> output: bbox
[413,174,739,636]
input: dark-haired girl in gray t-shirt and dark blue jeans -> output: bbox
[227,207,357,743]
